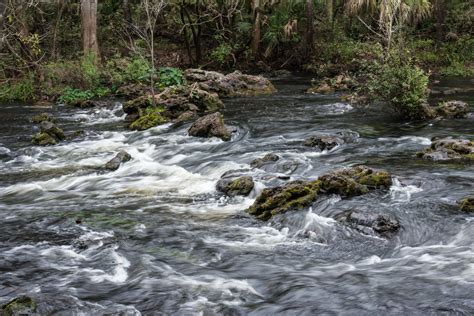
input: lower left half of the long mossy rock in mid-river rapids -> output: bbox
[247,180,321,220]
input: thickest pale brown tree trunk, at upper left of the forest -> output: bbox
[81,0,99,58]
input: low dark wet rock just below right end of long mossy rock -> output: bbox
[336,210,400,238]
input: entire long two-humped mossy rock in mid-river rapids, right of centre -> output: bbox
[247,166,392,220]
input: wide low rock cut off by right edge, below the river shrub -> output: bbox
[416,138,474,161]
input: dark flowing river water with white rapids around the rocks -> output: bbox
[0,76,474,315]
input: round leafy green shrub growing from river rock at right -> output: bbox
[369,57,433,119]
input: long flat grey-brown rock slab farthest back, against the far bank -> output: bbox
[184,69,276,97]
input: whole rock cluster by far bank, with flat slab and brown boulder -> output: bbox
[123,69,276,140]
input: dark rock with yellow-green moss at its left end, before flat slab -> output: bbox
[122,86,224,130]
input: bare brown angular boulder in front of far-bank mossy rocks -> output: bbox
[188,112,231,141]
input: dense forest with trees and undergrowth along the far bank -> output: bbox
[0,0,474,110]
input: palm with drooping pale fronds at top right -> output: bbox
[346,0,431,52]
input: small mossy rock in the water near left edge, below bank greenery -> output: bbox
[31,113,66,146]
